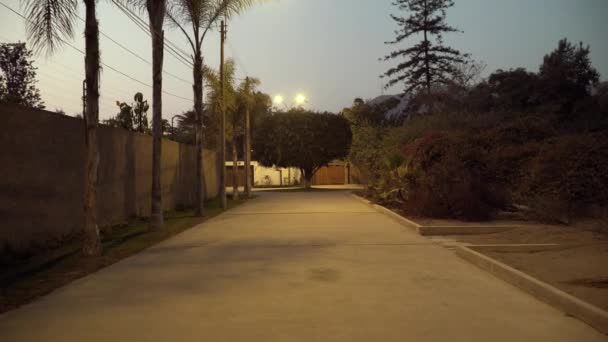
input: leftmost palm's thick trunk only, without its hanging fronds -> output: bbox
[82,0,101,256]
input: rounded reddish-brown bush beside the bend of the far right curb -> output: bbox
[403,133,505,221]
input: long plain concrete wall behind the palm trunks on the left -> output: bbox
[0,105,218,250]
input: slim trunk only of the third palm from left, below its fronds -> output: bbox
[193,48,205,216]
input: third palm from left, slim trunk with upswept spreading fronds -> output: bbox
[167,0,254,216]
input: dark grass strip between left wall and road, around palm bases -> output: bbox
[0,199,247,313]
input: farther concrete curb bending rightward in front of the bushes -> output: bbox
[352,194,517,236]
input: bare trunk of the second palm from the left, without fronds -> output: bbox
[147,0,166,230]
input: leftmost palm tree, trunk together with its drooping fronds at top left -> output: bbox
[25,0,101,256]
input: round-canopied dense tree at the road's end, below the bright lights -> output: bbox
[253,108,352,188]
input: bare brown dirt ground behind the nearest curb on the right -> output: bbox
[446,221,608,310]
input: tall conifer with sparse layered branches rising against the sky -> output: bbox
[382,0,467,94]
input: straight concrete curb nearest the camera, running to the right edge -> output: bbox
[456,246,608,335]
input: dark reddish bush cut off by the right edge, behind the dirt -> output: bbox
[522,132,608,223]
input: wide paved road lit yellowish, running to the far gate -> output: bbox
[0,191,608,342]
